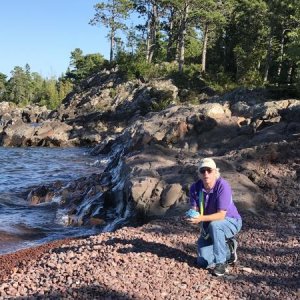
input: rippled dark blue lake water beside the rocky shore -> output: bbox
[0,147,105,254]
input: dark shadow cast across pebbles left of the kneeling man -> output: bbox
[105,238,196,267]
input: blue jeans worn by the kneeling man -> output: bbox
[197,218,242,268]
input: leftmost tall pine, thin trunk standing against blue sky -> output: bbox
[89,0,132,62]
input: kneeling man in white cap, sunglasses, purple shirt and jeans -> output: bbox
[188,158,242,276]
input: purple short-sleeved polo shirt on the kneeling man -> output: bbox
[190,177,241,219]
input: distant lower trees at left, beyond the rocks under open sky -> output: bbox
[0,48,105,109]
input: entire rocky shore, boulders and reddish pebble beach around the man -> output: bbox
[0,72,300,299]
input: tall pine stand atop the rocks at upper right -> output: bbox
[90,0,300,85]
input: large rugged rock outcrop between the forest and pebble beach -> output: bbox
[4,71,300,228]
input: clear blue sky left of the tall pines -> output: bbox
[0,0,109,78]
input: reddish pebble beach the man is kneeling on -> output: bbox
[0,211,300,299]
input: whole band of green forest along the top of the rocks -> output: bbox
[0,0,300,108]
